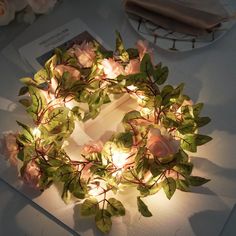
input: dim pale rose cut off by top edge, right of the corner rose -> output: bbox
[27,0,57,14]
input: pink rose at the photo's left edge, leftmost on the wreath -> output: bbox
[0,132,19,166]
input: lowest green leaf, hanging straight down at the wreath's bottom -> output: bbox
[95,210,112,233]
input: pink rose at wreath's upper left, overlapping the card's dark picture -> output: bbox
[72,41,96,67]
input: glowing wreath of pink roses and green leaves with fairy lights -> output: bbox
[0,33,211,233]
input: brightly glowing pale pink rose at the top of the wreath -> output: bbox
[102,58,124,79]
